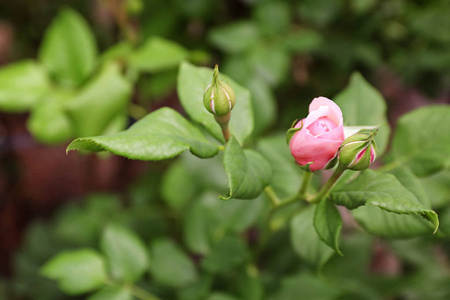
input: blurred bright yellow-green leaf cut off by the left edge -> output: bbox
[0,60,50,112]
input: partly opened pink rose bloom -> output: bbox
[289,97,344,171]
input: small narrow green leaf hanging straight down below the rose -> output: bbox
[314,199,342,255]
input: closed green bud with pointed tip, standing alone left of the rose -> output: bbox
[203,65,236,116]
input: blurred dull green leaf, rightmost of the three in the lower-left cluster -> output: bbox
[150,239,198,288]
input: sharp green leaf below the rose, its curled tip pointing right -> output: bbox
[331,170,439,230]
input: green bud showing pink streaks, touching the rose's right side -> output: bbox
[339,130,377,171]
